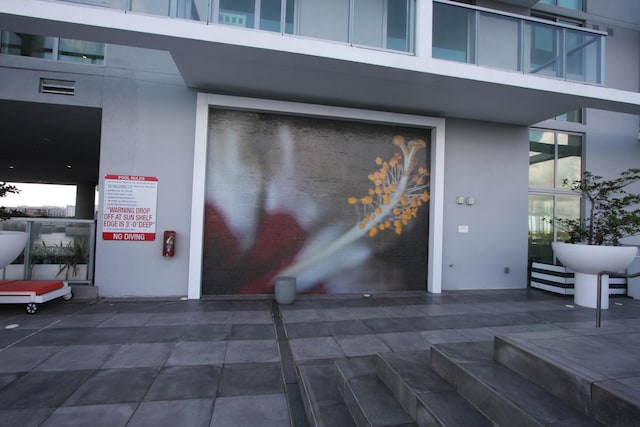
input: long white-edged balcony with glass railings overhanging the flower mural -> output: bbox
[0,0,640,126]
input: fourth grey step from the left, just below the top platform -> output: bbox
[430,342,601,427]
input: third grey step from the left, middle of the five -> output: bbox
[376,350,493,427]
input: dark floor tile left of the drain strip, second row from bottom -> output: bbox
[218,362,284,396]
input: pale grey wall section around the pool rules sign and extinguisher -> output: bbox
[95,46,196,297]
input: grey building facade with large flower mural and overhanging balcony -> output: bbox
[0,0,640,298]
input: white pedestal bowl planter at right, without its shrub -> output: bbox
[551,242,638,309]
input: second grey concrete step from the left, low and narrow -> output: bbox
[335,357,417,427]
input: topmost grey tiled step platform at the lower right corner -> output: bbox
[495,328,640,426]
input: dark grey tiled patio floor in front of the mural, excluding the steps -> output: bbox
[0,289,640,427]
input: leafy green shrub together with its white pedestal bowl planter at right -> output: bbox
[552,168,640,308]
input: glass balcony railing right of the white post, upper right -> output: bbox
[432,1,604,84]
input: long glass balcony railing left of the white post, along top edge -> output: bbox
[59,0,416,53]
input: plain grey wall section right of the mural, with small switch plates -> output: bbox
[442,119,528,290]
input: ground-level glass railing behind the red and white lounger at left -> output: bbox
[0,218,96,284]
